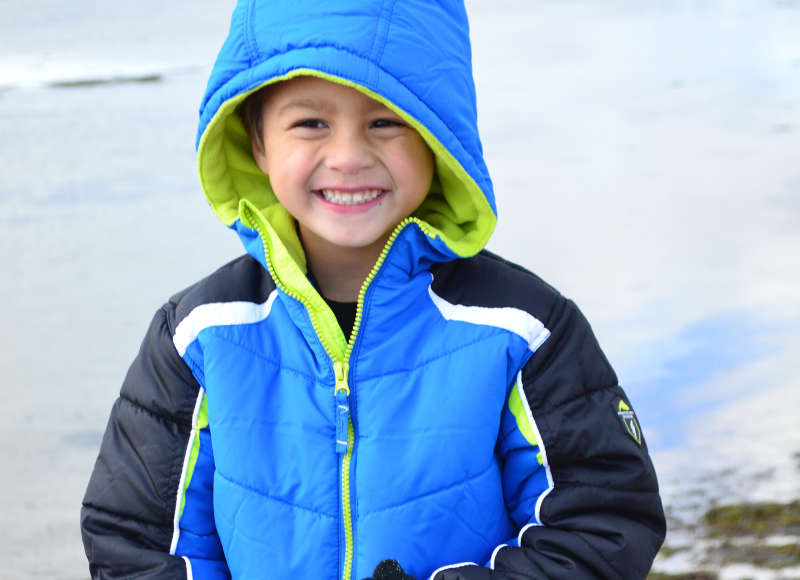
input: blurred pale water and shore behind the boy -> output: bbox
[0,0,800,579]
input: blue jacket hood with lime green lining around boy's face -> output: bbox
[196,0,496,269]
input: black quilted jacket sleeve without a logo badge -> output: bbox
[81,304,200,580]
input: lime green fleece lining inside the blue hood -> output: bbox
[197,69,497,272]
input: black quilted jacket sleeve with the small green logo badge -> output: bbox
[435,298,666,580]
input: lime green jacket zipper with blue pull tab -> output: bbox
[243,205,435,580]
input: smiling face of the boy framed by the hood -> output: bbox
[253,77,434,251]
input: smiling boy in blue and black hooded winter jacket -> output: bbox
[82,0,664,580]
